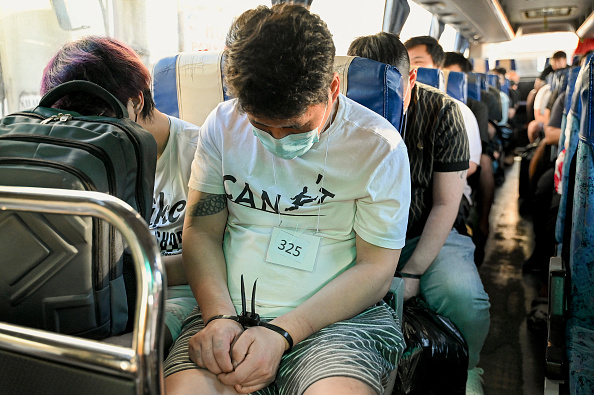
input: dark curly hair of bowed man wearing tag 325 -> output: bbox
[225,4,336,119]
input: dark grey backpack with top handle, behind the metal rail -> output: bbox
[0,81,157,338]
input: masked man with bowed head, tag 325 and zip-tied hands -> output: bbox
[165,4,410,394]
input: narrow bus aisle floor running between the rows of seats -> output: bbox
[479,158,546,395]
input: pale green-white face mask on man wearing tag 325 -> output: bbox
[247,103,328,159]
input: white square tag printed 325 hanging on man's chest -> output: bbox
[266,228,321,272]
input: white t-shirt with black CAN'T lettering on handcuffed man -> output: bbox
[189,95,410,318]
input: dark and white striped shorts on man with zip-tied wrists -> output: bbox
[164,301,405,395]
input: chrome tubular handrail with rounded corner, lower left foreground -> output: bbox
[0,186,165,394]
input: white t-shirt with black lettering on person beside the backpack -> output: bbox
[149,116,200,255]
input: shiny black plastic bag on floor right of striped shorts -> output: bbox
[393,297,468,395]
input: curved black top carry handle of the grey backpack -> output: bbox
[39,80,128,119]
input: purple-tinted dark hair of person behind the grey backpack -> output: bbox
[40,36,155,119]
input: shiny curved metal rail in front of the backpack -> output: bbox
[0,186,165,394]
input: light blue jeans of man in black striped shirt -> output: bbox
[398,230,491,369]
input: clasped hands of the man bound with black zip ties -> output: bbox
[189,320,287,394]
